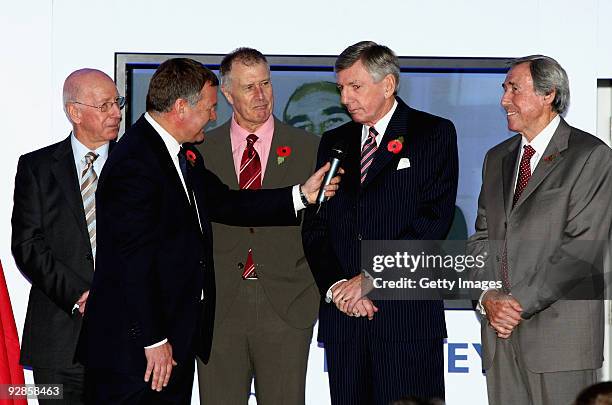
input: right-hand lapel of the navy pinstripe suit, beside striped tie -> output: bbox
[360,99,410,188]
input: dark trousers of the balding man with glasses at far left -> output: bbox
[32,364,85,405]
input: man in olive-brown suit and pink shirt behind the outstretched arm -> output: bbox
[198,48,320,405]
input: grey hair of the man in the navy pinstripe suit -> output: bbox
[334,41,400,94]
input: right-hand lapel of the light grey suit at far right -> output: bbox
[514,118,571,208]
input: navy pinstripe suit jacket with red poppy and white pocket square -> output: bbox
[303,98,458,342]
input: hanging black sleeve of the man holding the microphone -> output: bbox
[100,159,168,347]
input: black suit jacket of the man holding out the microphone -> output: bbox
[82,117,297,374]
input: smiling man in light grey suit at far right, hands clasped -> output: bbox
[468,55,612,404]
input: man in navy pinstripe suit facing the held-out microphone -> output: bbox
[303,41,458,405]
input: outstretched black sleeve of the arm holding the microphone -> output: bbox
[195,152,298,226]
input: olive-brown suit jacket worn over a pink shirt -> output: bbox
[199,119,320,328]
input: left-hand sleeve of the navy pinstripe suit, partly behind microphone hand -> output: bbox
[302,135,346,297]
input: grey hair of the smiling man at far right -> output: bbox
[510,55,570,114]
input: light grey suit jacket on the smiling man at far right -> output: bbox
[468,118,612,373]
